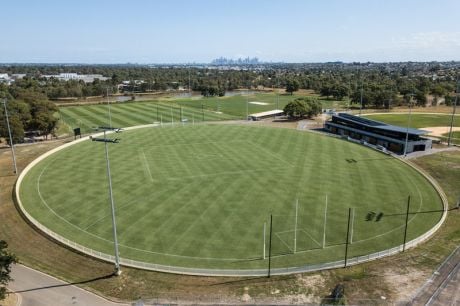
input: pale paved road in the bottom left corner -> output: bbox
[8,265,129,306]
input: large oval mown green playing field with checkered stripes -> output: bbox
[20,125,441,269]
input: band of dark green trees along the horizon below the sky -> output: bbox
[0,62,460,141]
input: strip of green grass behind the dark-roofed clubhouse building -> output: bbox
[365,113,460,128]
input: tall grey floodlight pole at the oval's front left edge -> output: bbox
[91,127,121,275]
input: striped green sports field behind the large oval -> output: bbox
[55,93,345,133]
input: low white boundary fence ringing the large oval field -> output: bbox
[15,125,448,276]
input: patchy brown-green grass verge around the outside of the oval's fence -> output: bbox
[0,128,460,304]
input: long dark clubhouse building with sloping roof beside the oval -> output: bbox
[324,113,432,154]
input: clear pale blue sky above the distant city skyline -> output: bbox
[0,0,460,64]
